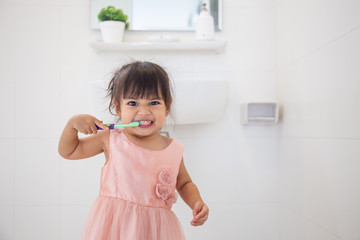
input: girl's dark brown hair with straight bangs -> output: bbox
[107,61,172,115]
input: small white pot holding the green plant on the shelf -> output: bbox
[100,21,125,42]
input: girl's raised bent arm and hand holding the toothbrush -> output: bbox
[58,114,109,160]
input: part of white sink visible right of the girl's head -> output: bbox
[169,80,230,124]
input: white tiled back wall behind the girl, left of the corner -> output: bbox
[0,0,278,240]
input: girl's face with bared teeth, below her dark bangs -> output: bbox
[117,94,169,137]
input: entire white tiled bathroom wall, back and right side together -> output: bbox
[0,0,360,240]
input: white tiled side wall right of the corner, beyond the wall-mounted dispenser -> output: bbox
[277,0,360,240]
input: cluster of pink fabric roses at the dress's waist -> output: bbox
[155,168,178,205]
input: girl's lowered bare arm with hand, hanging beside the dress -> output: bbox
[176,160,209,226]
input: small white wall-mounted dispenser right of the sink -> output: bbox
[241,102,279,125]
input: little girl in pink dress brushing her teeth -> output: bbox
[59,62,209,240]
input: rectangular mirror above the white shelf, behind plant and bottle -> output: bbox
[90,0,222,31]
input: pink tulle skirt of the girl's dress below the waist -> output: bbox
[82,196,185,240]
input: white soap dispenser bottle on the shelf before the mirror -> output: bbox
[195,3,215,41]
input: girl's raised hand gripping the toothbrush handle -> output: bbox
[70,114,109,134]
